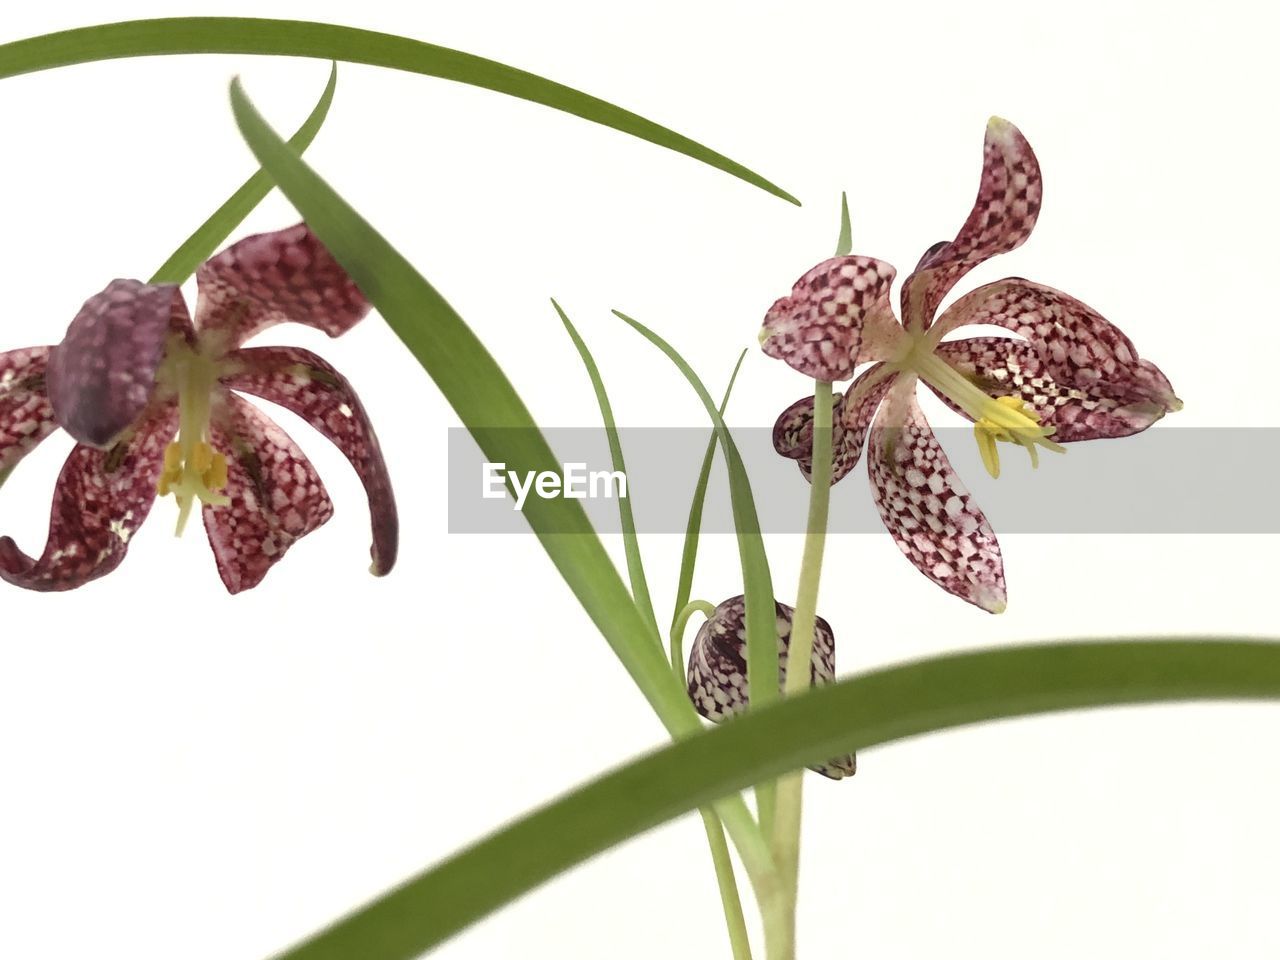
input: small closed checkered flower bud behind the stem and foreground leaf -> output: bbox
[689,596,856,780]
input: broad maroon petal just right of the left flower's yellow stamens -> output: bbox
[204,393,333,594]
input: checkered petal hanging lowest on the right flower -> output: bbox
[868,376,1005,613]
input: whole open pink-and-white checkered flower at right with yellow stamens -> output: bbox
[760,118,1181,613]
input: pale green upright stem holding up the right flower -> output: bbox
[773,380,832,956]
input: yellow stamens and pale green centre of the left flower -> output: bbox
[156,338,230,536]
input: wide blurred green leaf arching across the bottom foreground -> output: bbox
[272,640,1280,960]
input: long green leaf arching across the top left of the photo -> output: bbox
[0,17,800,206]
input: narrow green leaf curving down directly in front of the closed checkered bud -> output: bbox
[613,310,781,833]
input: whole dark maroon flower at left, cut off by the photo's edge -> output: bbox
[0,224,398,593]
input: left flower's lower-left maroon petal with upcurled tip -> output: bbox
[0,406,178,591]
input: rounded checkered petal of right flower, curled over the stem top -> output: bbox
[760,256,897,380]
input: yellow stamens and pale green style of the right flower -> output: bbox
[896,335,1066,476]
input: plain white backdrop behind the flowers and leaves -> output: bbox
[0,0,1280,960]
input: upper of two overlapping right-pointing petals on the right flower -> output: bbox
[936,278,1181,411]
